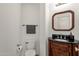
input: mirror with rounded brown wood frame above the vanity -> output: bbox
[52,10,74,31]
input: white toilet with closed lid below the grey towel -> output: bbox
[25,41,36,56]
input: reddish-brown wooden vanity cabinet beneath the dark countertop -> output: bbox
[48,39,79,56]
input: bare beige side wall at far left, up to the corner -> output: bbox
[0,3,21,56]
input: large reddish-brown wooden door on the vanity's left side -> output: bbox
[52,42,71,56]
